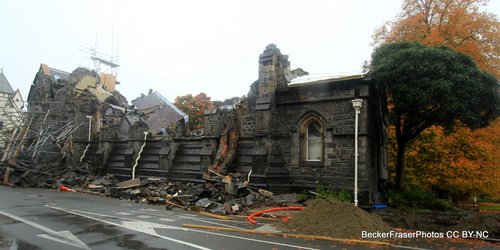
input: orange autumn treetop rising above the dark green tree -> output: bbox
[373,0,500,79]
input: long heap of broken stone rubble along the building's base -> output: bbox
[0,160,286,215]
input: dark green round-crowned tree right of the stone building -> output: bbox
[370,42,500,188]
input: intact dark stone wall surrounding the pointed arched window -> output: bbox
[270,79,380,198]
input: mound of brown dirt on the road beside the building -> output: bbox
[280,199,391,238]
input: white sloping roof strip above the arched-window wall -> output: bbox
[288,72,365,87]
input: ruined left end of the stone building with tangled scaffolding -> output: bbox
[23,64,127,162]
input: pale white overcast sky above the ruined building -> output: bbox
[0,0,500,101]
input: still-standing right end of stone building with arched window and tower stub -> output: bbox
[202,44,387,201]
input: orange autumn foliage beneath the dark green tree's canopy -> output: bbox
[389,119,500,198]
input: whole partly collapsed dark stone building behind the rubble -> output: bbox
[13,44,387,201]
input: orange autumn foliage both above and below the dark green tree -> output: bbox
[373,0,500,198]
